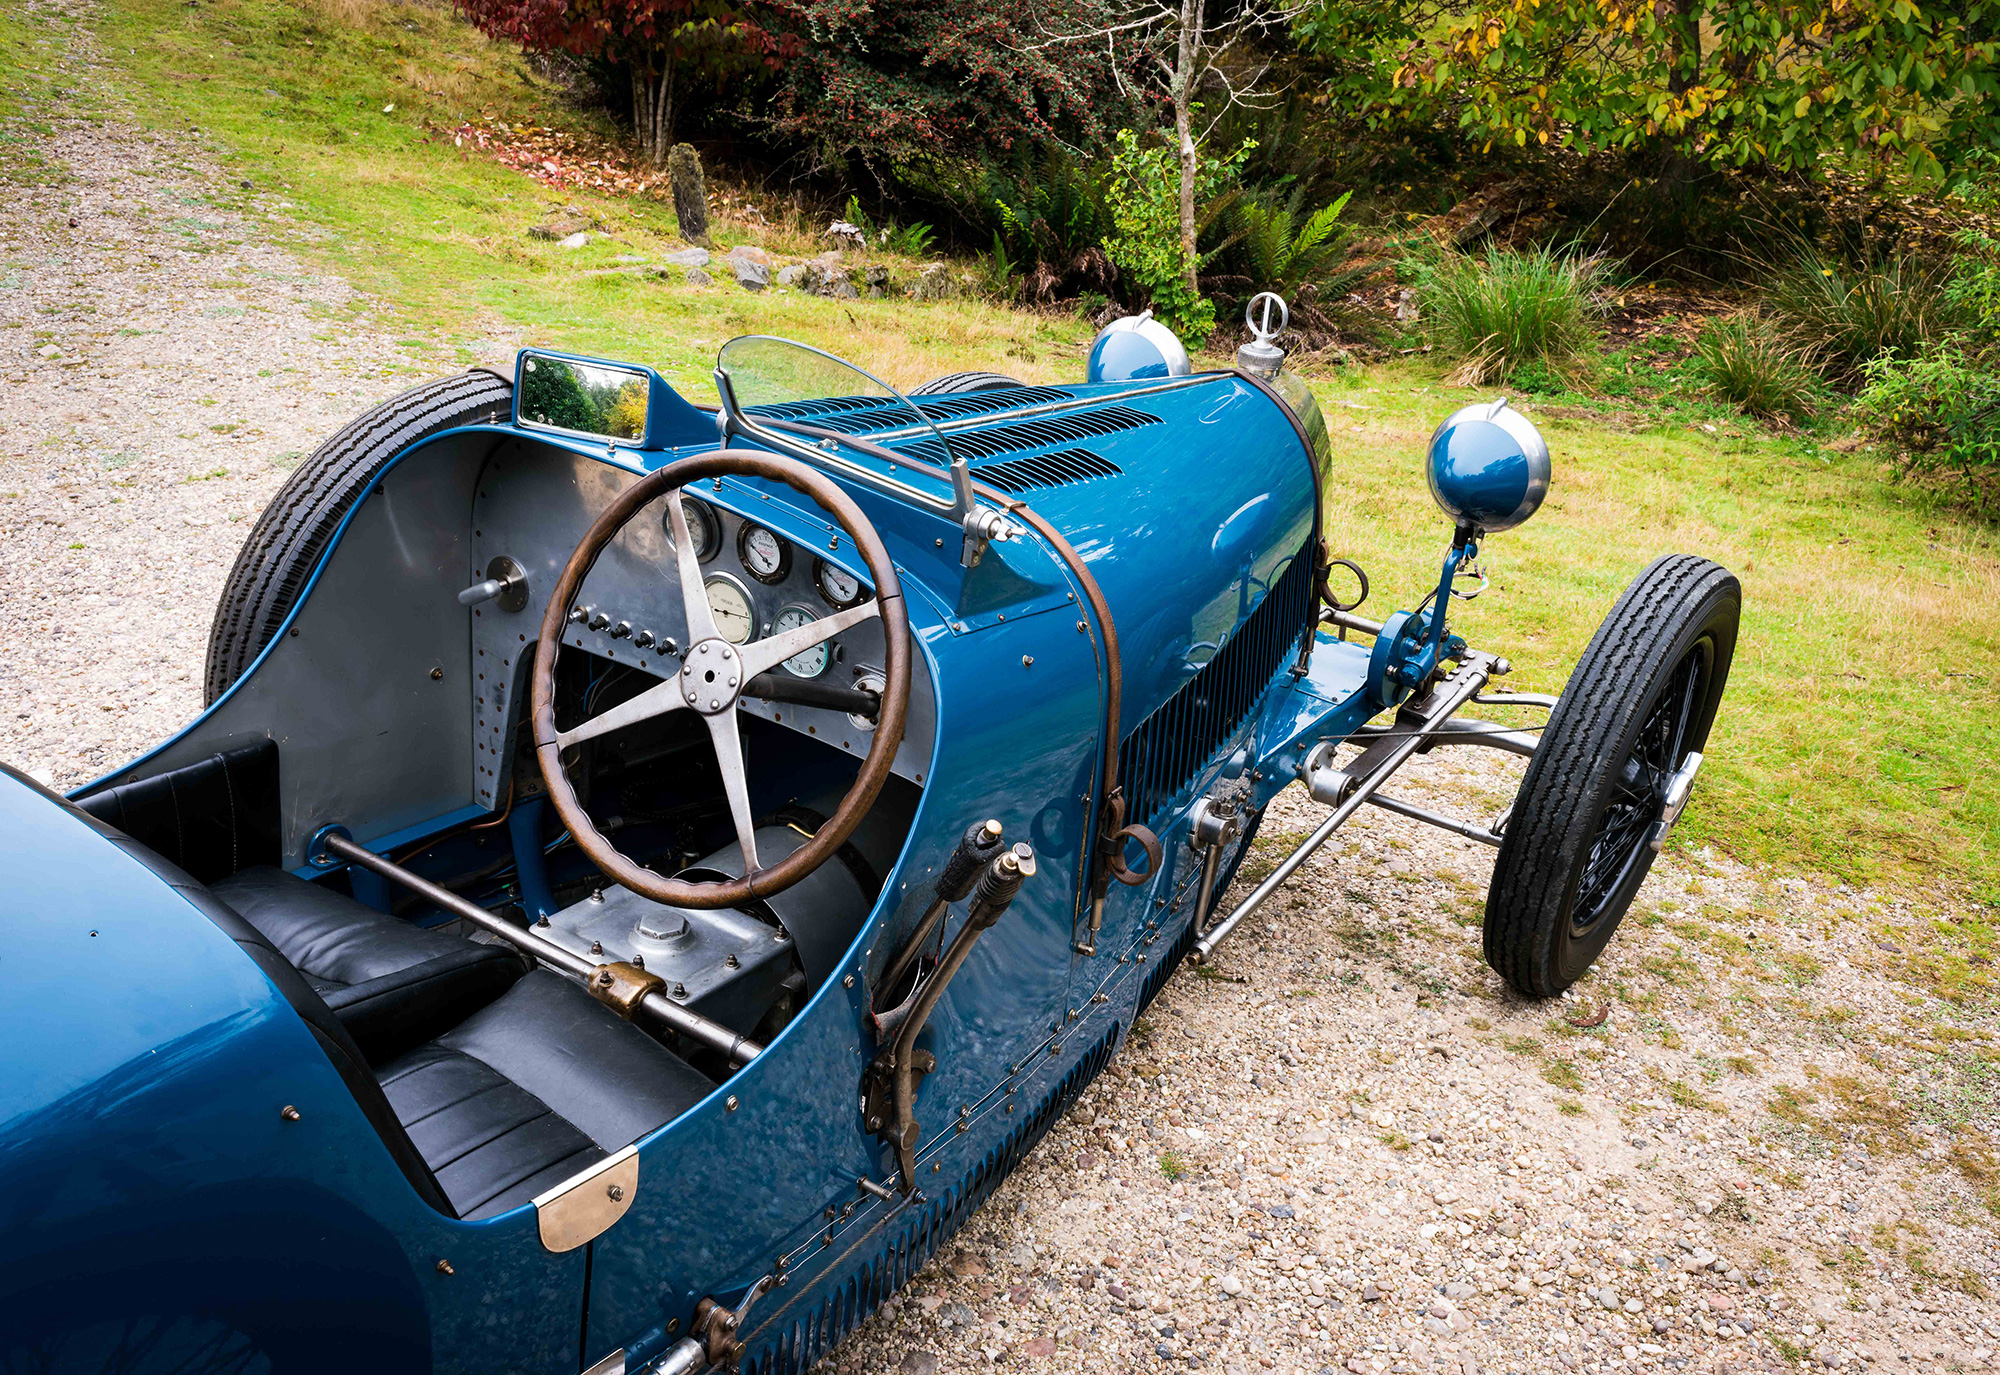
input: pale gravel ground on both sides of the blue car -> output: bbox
[0,0,2000,1375]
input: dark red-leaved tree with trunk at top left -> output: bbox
[456,0,798,164]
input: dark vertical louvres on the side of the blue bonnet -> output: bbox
[1118,550,1312,825]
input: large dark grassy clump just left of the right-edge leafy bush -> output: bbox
[1766,248,1964,386]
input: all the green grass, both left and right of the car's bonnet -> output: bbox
[70,0,2000,911]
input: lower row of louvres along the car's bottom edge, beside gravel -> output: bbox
[742,1023,1118,1375]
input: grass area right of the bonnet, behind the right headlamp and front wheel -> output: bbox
[1316,366,2000,903]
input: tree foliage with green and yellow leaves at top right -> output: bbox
[1300,0,2000,178]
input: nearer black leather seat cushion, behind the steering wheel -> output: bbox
[378,969,714,1219]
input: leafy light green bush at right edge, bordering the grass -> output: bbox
[1856,342,2000,516]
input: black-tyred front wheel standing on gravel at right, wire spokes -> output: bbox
[1486,554,1742,997]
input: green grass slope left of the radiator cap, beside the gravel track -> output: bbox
[90,0,1090,400]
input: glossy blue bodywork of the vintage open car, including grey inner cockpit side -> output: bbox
[0,353,1450,1375]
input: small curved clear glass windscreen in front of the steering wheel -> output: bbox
[716,334,952,489]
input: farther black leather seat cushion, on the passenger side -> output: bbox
[210,865,526,1065]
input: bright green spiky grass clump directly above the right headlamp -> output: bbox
[1418,248,1608,386]
